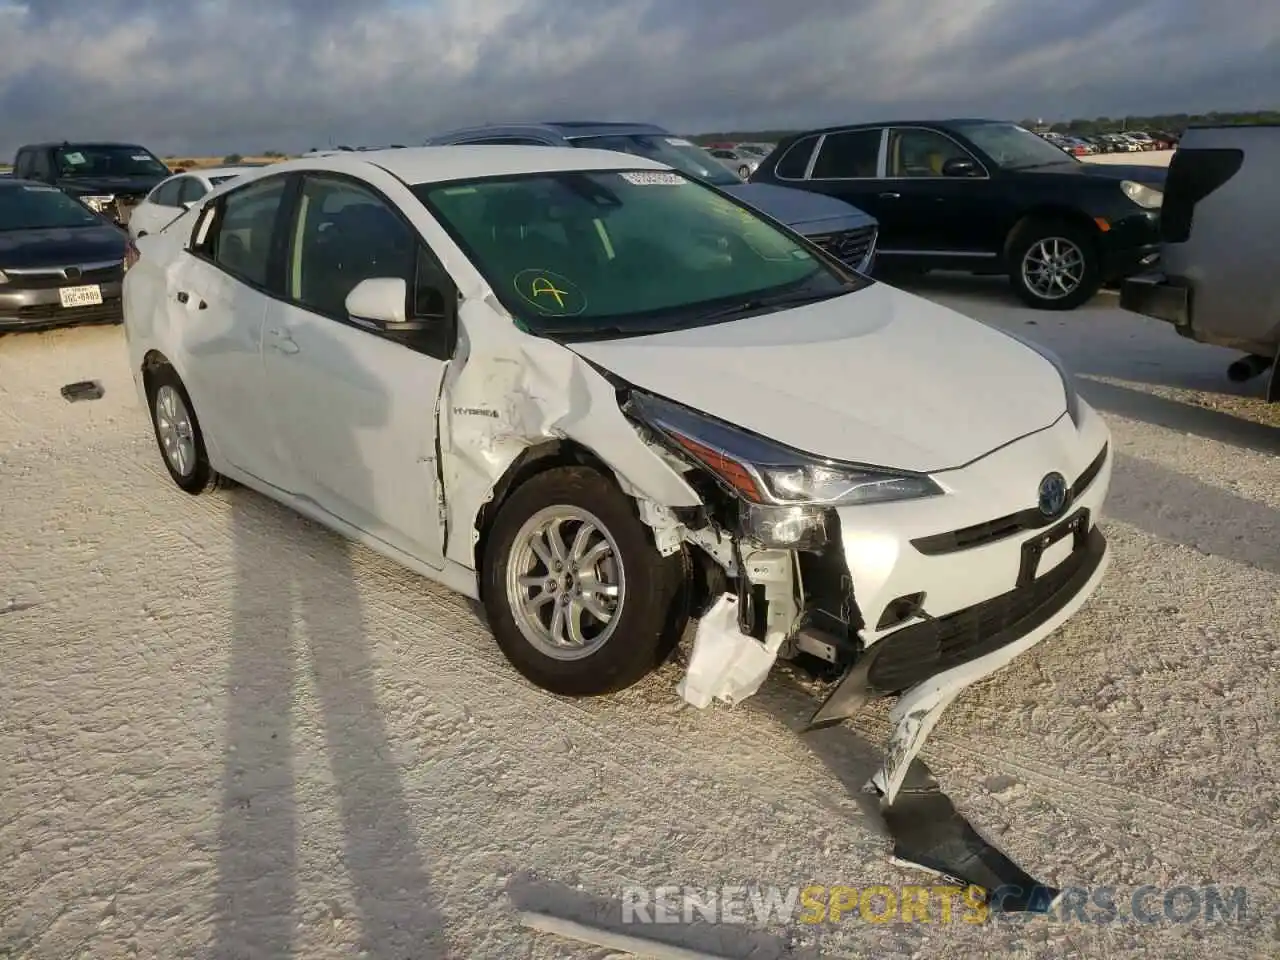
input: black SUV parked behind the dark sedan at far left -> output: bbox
[13,141,173,227]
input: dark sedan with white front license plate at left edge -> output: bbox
[0,177,128,330]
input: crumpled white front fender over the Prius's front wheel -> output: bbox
[436,302,701,568]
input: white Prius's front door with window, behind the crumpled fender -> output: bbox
[264,174,452,566]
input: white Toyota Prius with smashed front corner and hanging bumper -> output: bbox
[124,146,1111,801]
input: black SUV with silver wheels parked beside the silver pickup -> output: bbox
[751,120,1167,310]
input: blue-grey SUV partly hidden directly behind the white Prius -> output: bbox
[426,123,877,274]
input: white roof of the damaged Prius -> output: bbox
[269,146,669,184]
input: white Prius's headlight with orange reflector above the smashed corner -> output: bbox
[627,393,943,549]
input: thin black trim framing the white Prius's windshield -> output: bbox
[408,166,876,343]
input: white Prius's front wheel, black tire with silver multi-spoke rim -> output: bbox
[481,466,690,696]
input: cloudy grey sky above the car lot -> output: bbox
[0,0,1280,159]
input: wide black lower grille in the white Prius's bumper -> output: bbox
[867,527,1106,692]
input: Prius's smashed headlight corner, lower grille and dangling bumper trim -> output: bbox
[623,392,1107,911]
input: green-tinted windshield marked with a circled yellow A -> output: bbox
[413,170,870,339]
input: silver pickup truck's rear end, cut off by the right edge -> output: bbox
[1120,124,1280,402]
